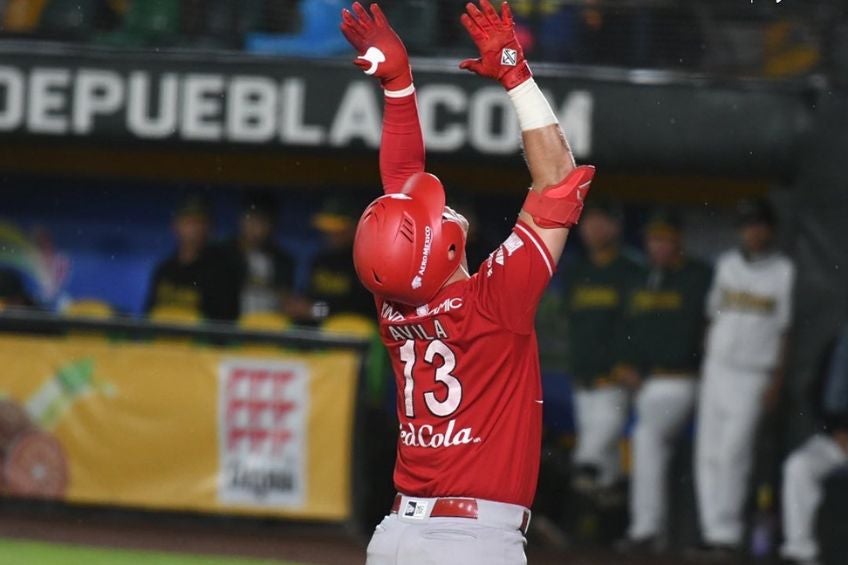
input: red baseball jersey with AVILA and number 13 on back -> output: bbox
[377,222,555,507]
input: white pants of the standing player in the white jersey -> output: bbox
[695,361,770,545]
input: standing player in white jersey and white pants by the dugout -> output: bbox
[695,199,795,555]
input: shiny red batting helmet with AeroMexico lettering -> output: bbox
[353,173,465,306]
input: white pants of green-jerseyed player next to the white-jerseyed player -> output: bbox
[628,375,698,540]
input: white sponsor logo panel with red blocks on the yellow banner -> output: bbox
[218,358,309,508]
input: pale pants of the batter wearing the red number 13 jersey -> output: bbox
[365,497,527,565]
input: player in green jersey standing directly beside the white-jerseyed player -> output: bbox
[618,210,710,552]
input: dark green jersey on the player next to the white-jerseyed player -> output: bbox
[625,259,712,375]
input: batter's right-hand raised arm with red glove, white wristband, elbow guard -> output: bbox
[459,0,594,261]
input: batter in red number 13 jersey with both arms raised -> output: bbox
[342,0,594,565]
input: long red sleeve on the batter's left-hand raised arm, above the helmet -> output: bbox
[380,93,424,194]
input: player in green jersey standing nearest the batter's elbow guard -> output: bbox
[564,200,640,493]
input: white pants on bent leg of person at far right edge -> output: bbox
[780,434,848,561]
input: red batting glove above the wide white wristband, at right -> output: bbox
[459,0,533,90]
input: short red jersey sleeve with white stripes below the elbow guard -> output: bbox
[477,222,556,334]
